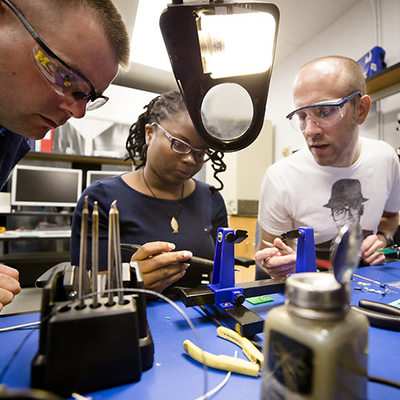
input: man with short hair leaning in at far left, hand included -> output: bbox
[0,0,130,310]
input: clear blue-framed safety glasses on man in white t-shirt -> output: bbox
[286,91,361,133]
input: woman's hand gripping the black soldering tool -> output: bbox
[131,242,193,293]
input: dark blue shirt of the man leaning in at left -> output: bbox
[0,125,30,189]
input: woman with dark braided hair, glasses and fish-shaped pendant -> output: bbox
[71,91,228,292]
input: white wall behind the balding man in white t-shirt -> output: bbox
[266,0,400,161]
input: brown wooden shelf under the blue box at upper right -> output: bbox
[366,63,400,101]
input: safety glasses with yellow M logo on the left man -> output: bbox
[1,0,108,111]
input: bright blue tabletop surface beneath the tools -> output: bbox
[0,262,400,400]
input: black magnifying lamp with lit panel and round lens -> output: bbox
[160,0,279,152]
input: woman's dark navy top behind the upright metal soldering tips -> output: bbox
[71,176,228,286]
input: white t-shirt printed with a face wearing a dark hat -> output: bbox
[258,138,400,244]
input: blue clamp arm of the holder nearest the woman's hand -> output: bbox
[207,228,247,308]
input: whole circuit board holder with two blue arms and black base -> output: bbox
[181,228,317,337]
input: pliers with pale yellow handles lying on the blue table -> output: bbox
[183,326,264,377]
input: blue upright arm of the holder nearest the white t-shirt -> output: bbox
[296,227,317,273]
